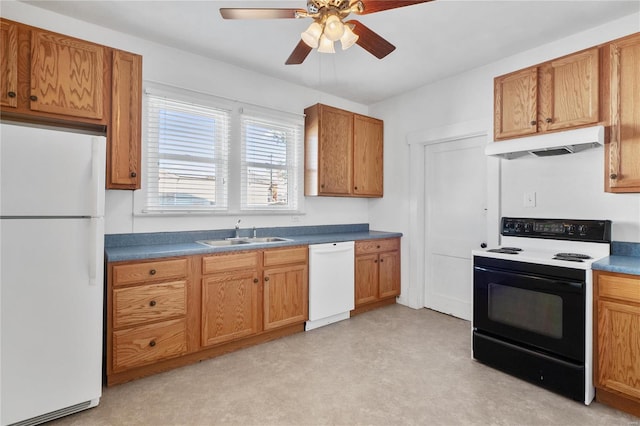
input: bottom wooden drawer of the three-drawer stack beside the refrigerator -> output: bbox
[113,319,187,371]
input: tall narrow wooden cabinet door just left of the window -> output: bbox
[107,50,142,189]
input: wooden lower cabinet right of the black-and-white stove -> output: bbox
[594,271,640,417]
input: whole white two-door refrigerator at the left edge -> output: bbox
[0,123,106,426]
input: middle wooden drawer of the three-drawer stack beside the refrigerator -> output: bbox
[113,281,187,328]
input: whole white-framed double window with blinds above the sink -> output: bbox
[144,84,304,214]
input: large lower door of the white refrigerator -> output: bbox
[0,218,104,425]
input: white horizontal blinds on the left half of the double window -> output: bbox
[146,94,230,211]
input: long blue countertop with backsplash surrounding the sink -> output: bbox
[105,224,402,262]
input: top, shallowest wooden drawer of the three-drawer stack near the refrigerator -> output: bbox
[113,259,189,287]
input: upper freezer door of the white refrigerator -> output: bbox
[0,123,106,217]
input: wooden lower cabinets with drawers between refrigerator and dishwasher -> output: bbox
[106,246,308,385]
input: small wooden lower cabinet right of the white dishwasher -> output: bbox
[351,238,400,314]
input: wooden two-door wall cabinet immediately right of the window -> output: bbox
[305,104,383,197]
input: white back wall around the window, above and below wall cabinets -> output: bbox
[1,0,369,234]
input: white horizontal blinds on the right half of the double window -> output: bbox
[240,108,304,211]
